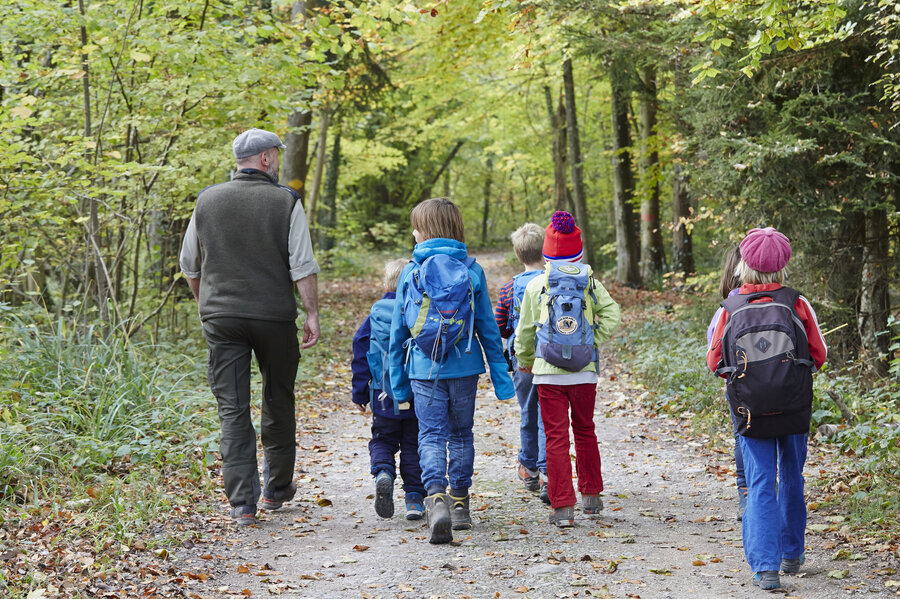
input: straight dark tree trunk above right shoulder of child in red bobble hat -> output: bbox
[609,64,641,286]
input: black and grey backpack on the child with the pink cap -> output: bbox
[716,287,815,439]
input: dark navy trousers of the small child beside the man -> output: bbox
[369,413,425,495]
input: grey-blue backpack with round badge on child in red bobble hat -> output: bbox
[535,262,599,372]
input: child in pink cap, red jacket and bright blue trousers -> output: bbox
[706,227,827,590]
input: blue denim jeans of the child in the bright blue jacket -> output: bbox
[410,374,478,490]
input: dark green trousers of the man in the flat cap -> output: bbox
[203,318,300,506]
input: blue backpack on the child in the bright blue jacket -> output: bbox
[403,254,475,368]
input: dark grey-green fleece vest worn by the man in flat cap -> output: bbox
[194,170,297,322]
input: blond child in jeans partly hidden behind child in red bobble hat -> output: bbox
[494,223,550,503]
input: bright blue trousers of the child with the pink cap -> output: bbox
[740,434,808,572]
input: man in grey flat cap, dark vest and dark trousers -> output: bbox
[180,129,319,526]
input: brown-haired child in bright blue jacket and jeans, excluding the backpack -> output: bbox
[389,198,515,544]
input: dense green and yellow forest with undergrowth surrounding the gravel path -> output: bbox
[0,0,900,590]
